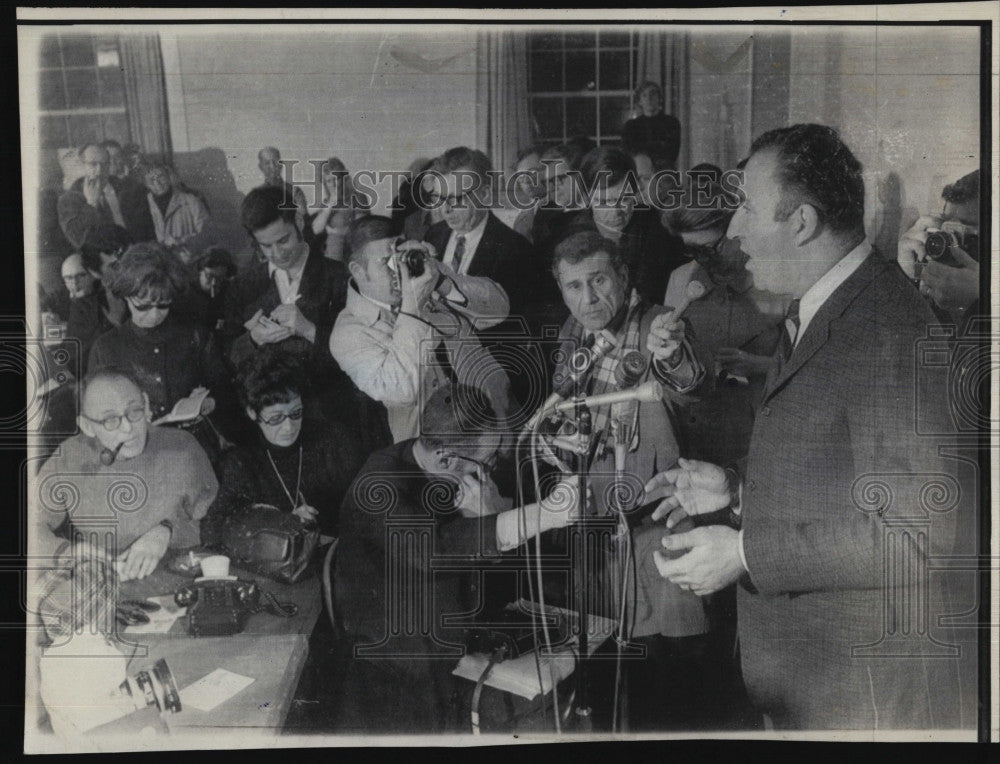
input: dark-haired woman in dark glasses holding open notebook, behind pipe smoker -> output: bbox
[88,242,231,463]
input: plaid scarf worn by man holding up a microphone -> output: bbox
[567,289,649,462]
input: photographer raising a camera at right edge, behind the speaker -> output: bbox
[897,170,979,323]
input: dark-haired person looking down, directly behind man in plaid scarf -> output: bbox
[566,146,689,305]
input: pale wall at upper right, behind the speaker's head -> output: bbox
[788,26,980,256]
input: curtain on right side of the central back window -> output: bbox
[636,29,691,170]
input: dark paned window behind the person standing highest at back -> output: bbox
[528,29,637,145]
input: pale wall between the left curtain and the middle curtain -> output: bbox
[161,27,476,251]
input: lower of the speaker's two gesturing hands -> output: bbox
[653,525,744,597]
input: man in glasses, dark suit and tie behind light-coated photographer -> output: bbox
[421,146,552,408]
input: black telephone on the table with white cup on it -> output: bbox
[174,579,298,637]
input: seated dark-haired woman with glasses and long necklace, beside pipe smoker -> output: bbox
[201,346,366,545]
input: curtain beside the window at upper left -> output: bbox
[120,34,173,162]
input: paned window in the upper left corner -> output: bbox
[38,34,131,149]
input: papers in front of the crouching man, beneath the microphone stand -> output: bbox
[451,600,615,700]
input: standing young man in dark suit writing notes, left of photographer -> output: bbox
[221,186,391,453]
